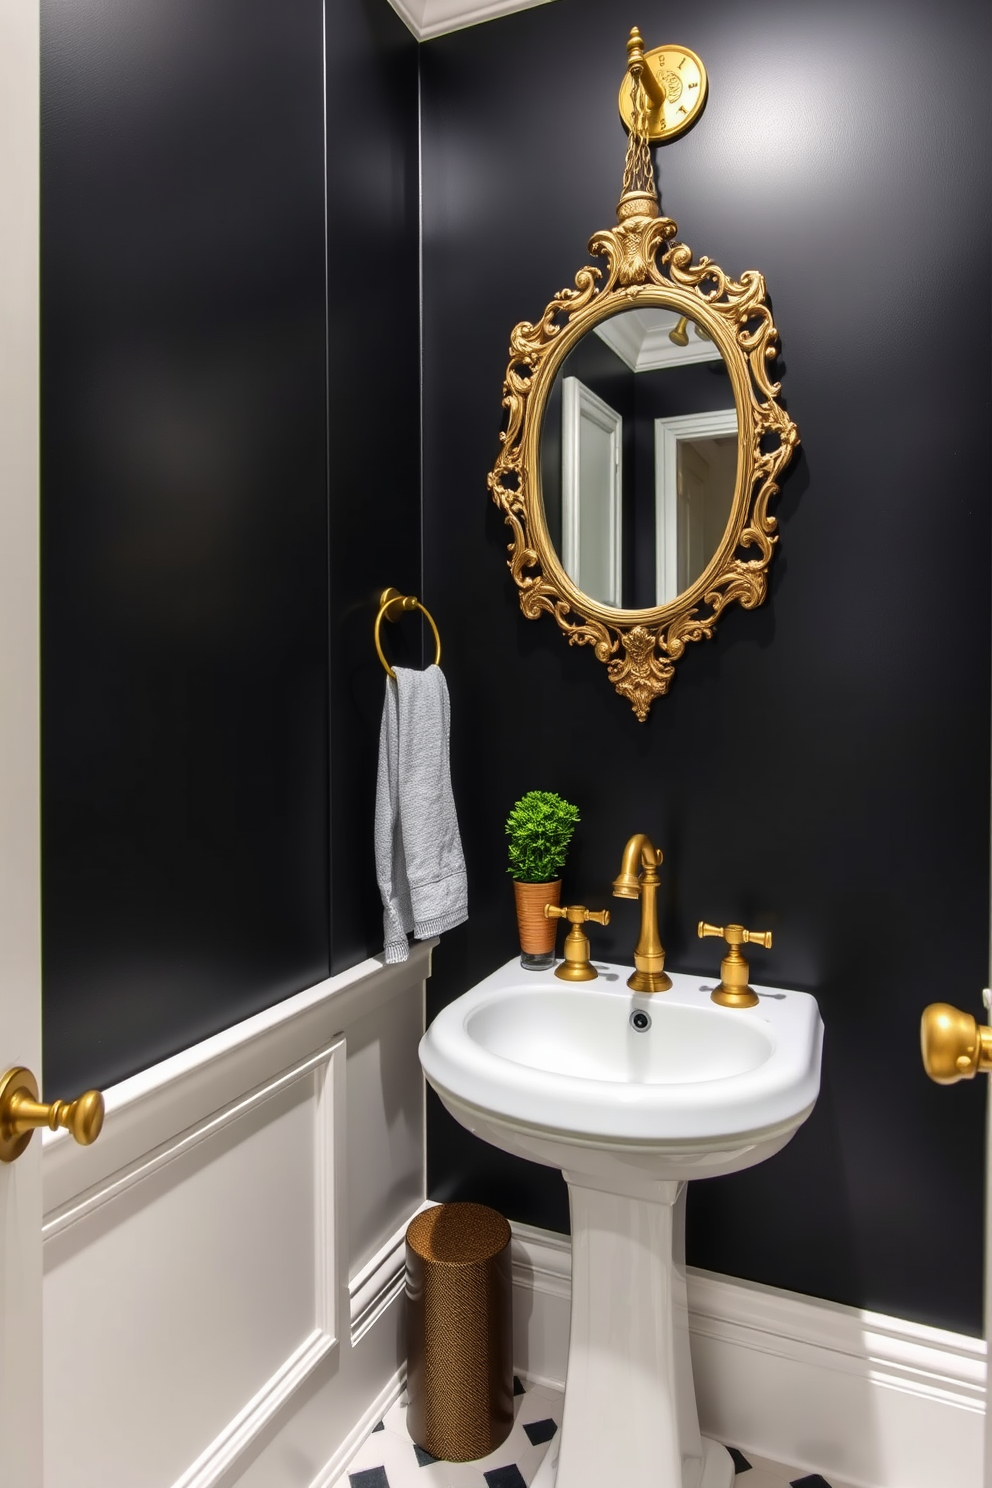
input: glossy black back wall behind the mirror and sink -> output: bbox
[421,0,992,1333]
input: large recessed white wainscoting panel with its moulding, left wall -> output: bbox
[45,1043,344,1488]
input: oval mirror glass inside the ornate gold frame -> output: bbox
[540,307,738,610]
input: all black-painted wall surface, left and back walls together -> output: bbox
[42,0,991,1332]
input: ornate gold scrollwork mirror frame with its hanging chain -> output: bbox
[488,29,799,722]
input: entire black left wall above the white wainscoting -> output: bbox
[42,0,419,1094]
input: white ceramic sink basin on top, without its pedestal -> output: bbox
[421,961,822,1180]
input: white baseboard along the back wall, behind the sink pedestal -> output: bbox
[513,1225,986,1488]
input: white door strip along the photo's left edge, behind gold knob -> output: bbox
[0,0,42,1488]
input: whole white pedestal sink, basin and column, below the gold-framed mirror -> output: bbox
[419,960,822,1488]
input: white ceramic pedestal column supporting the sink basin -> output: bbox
[534,1173,733,1488]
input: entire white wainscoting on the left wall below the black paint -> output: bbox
[43,943,431,1488]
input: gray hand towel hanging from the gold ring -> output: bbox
[375,667,468,961]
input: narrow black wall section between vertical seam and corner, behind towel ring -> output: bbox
[327,0,422,970]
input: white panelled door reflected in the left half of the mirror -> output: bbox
[562,376,623,609]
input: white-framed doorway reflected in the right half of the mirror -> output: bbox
[654,408,738,604]
